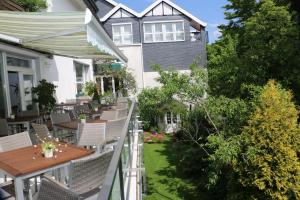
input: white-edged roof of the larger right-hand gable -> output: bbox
[140,0,207,27]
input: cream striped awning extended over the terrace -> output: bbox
[0,9,127,63]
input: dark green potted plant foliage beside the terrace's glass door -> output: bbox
[32,79,57,112]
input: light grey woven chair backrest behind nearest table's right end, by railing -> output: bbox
[77,123,106,146]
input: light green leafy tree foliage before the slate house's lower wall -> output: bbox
[138,62,207,130]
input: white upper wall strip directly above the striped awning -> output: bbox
[47,0,85,12]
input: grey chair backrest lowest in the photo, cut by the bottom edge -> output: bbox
[37,178,80,200]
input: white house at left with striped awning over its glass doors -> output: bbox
[0,0,127,117]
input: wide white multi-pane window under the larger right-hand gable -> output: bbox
[144,21,185,42]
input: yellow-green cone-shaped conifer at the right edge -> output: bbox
[233,81,300,199]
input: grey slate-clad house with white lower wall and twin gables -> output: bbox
[95,0,207,91]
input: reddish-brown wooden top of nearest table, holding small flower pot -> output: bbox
[0,143,94,177]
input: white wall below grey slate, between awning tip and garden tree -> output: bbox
[119,45,144,92]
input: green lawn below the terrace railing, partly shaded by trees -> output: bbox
[144,135,199,200]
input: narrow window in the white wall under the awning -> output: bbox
[75,63,89,96]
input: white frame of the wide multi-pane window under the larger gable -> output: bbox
[143,20,185,43]
